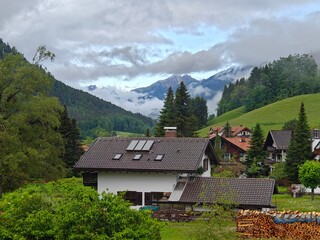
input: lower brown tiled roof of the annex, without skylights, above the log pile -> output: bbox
[180,177,275,207]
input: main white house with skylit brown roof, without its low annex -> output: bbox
[75,137,215,206]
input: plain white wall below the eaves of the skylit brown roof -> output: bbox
[98,172,177,193]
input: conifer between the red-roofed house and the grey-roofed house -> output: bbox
[245,123,268,177]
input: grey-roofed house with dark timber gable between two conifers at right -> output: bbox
[264,130,291,165]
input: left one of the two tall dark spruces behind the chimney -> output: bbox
[154,87,174,137]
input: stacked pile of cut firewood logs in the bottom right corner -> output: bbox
[237,210,320,240]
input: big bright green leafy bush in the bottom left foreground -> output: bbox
[0,178,160,240]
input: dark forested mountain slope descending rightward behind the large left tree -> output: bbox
[0,38,155,138]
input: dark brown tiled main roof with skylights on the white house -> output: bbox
[74,137,214,172]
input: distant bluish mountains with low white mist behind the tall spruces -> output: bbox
[86,66,252,118]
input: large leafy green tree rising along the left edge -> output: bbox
[0,54,65,191]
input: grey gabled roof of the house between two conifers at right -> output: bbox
[265,130,291,150]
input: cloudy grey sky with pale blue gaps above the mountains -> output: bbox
[0,0,320,90]
